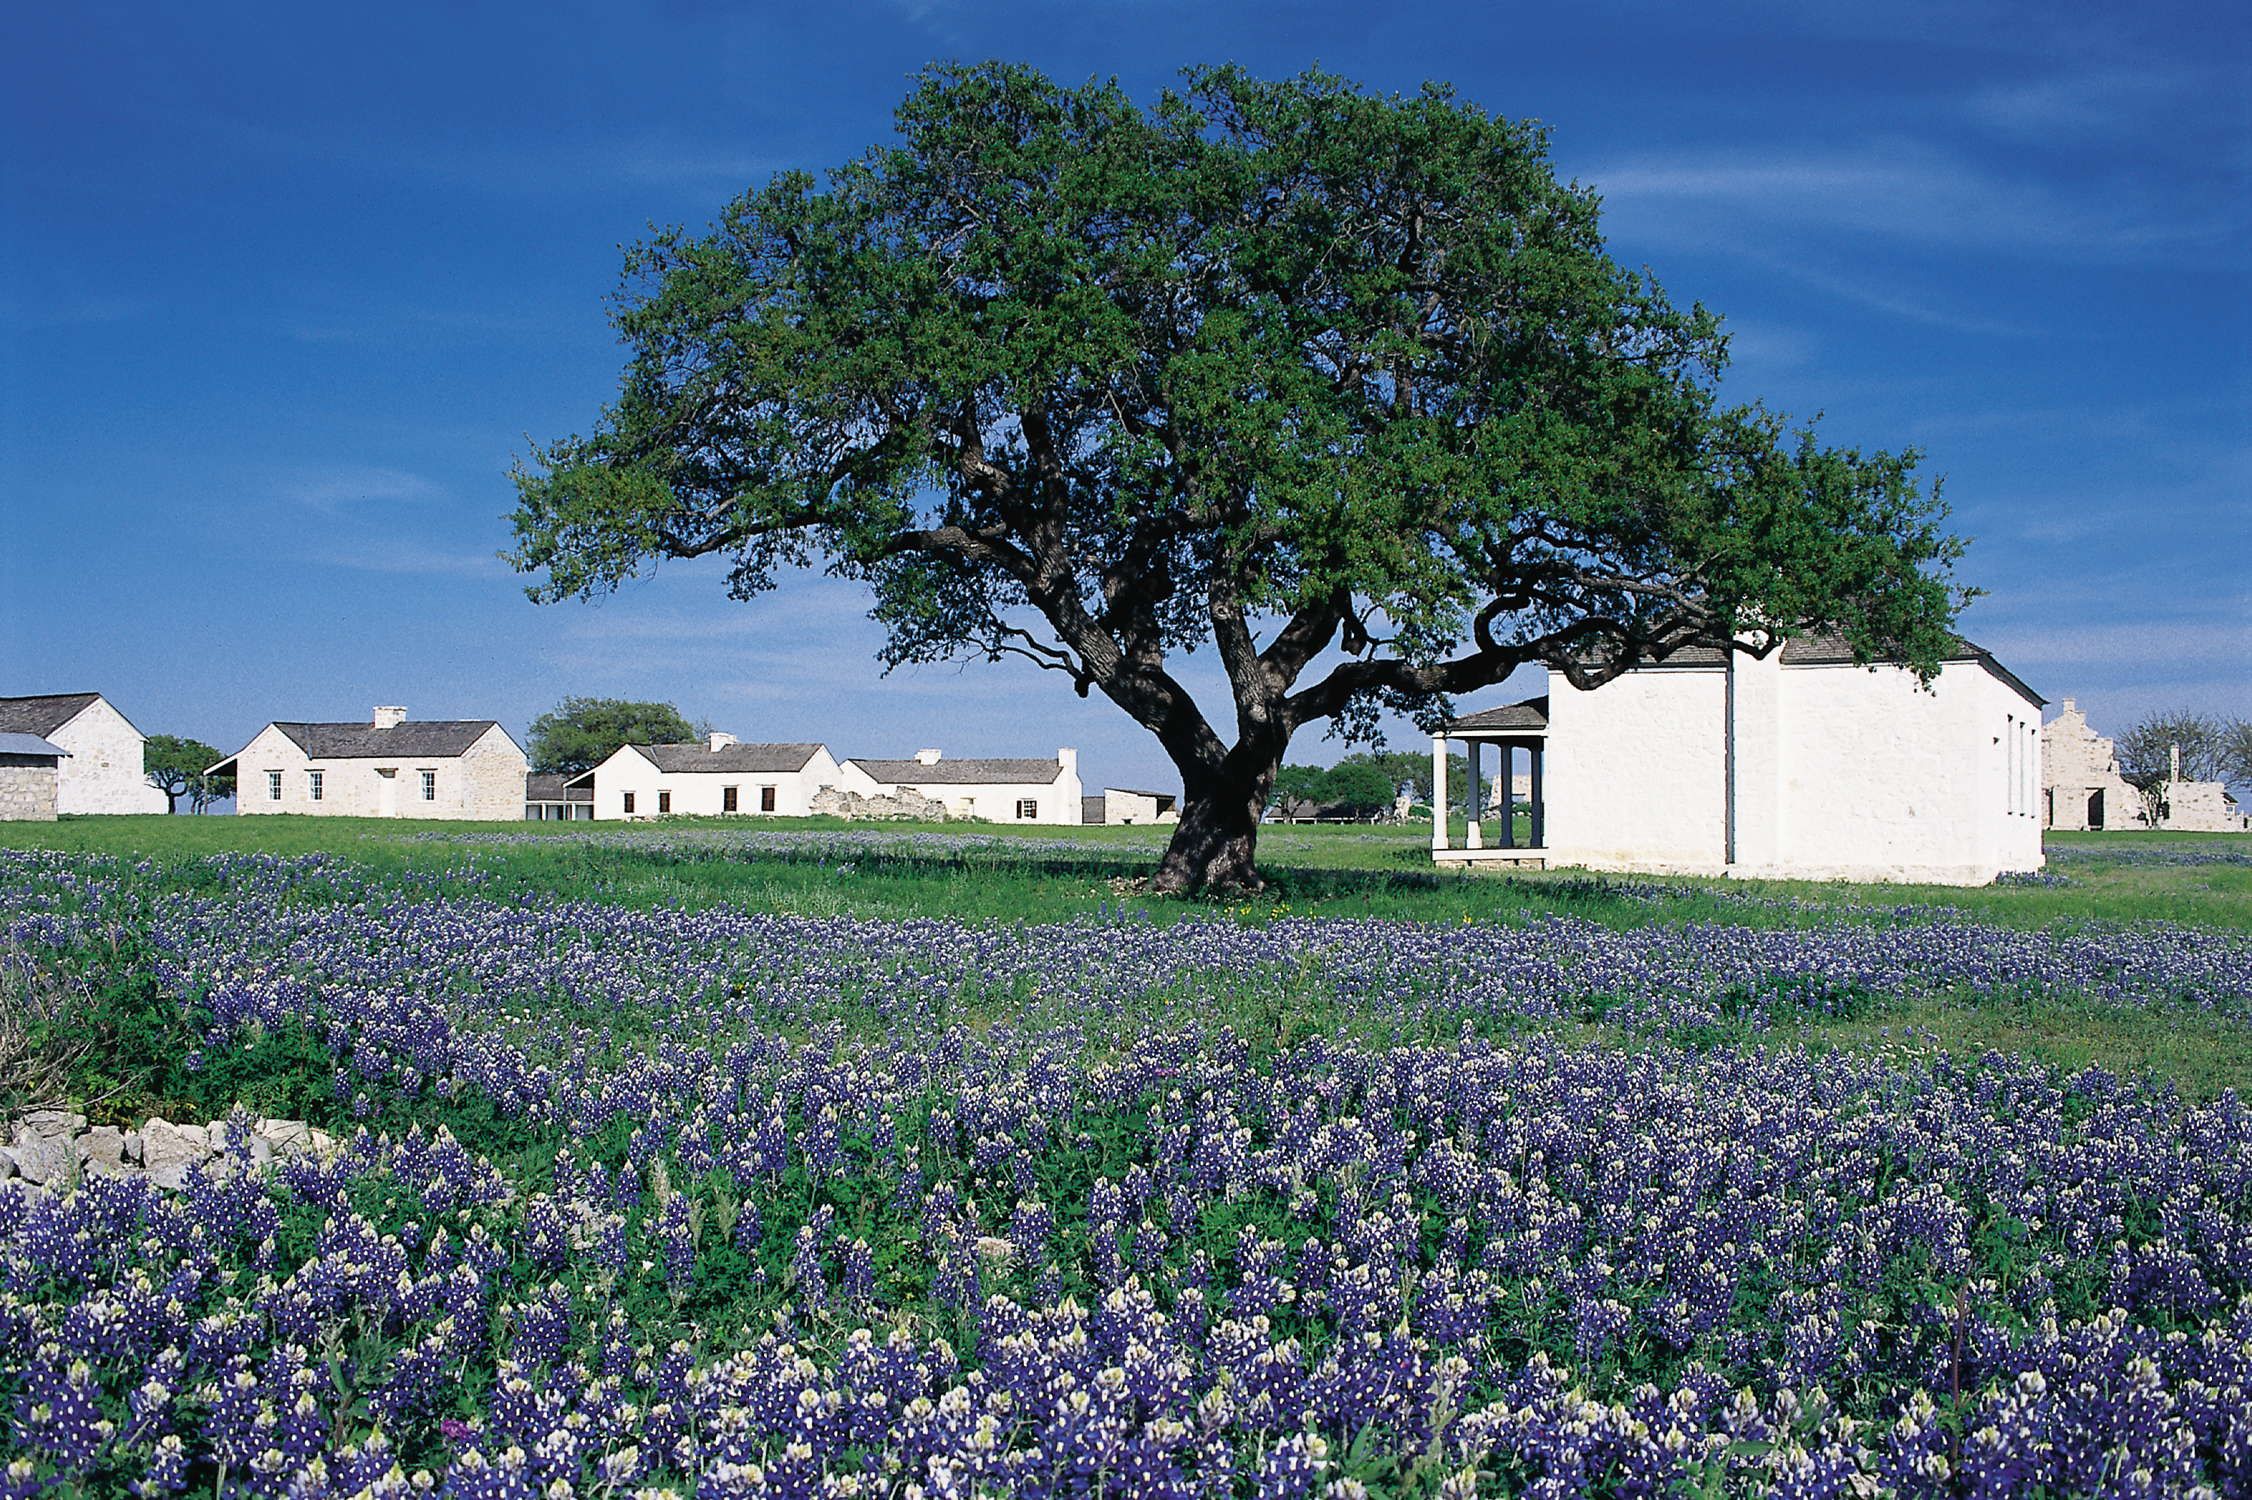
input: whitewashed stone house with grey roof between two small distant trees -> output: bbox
[212,707,529,820]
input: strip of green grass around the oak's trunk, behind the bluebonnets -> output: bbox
[0,815,2252,932]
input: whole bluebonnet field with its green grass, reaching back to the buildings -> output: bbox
[0,820,2252,1500]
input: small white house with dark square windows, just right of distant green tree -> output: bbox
[565,734,838,820]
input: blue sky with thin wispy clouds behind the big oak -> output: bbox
[0,0,2252,801]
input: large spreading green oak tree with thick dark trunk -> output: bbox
[511,63,1964,890]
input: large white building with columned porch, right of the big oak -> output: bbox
[1432,640,2043,885]
